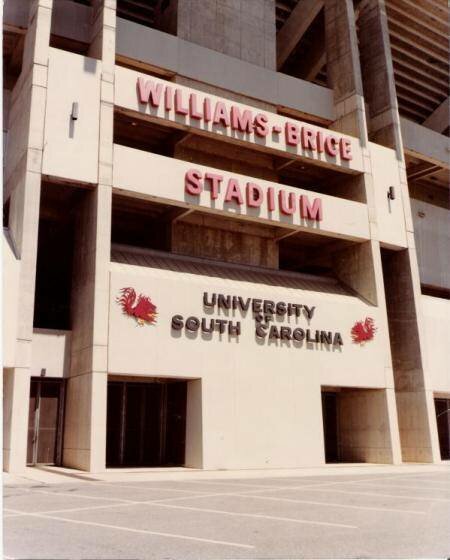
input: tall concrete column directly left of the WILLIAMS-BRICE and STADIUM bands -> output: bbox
[63,0,116,472]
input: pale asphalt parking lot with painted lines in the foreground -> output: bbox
[3,469,450,560]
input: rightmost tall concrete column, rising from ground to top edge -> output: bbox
[358,0,440,462]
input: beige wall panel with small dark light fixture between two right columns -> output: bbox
[369,142,407,247]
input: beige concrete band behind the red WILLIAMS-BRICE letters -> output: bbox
[115,66,364,172]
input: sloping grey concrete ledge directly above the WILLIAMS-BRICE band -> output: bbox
[116,18,335,122]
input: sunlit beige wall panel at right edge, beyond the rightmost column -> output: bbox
[421,296,450,393]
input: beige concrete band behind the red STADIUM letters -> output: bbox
[113,144,370,239]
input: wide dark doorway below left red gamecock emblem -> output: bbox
[106,380,187,467]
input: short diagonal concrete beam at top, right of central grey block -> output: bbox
[277,0,323,69]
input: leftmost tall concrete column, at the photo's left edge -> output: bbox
[4,0,53,472]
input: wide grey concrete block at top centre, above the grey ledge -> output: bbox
[174,0,276,70]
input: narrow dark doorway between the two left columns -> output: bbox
[27,378,64,465]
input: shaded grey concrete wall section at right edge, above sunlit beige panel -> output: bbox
[411,198,450,289]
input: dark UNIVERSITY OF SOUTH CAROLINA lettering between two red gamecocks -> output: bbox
[171,292,344,347]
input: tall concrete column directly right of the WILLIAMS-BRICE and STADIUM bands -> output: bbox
[324,0,400,463]
